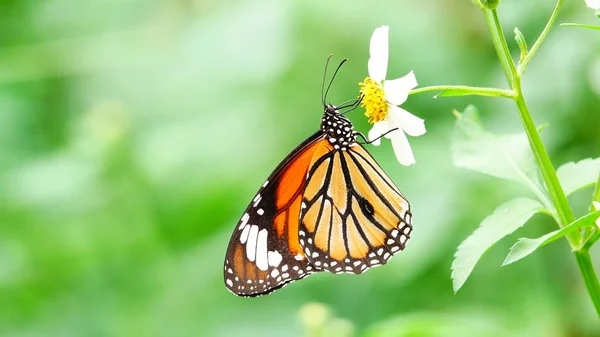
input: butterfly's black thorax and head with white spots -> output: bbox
[321,104,356,150]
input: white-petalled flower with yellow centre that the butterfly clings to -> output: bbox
[360,26,425,166]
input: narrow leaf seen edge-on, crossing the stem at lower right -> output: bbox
[502,211,600,266]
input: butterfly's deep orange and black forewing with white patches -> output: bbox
[224,131,327,296]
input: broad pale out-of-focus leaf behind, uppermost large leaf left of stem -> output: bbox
[451,106,547,200]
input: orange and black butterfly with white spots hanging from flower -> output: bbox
[224,55,412,297]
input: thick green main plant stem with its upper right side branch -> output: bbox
[482,0,600,316]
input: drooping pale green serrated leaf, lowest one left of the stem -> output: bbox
[452,198,544,292]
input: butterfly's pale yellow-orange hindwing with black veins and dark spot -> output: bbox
[299,144,412,274]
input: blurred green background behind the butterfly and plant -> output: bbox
[0,0,600,337]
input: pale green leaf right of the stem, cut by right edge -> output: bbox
[556,158,600,195]
